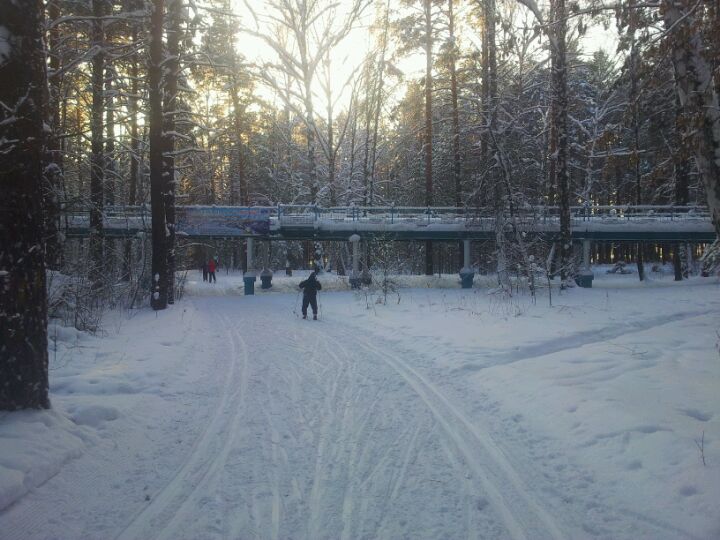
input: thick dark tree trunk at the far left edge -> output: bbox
[0,0,50,410]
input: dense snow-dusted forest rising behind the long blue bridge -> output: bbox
[0,0,720,408]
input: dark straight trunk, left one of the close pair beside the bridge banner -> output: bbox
[148,0,168,310]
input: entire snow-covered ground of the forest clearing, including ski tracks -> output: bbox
[0,269,720,540]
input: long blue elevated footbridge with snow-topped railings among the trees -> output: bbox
[63,205,715,243]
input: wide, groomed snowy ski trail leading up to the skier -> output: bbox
[118,299,563,539]
